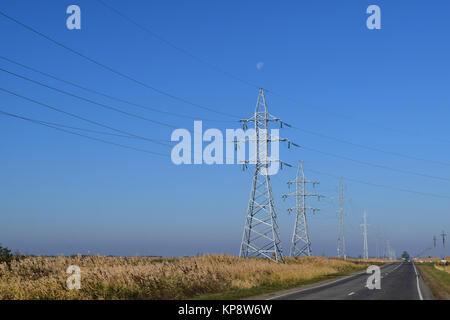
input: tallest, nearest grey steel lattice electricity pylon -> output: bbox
[235,88,296,262]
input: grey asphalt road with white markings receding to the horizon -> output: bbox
[269,262,433,300]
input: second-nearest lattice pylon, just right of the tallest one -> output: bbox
[283,161,322,257]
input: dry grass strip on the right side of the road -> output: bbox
[418,262,450,300]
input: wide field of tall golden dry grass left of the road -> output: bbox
[0,255,367,299]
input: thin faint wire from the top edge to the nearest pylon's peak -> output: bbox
[97,0,261,89]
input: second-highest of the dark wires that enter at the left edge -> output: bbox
[0,56,234,122]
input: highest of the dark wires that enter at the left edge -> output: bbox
[0,11,240,118]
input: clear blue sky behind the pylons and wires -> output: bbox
[0,0,450,256]
